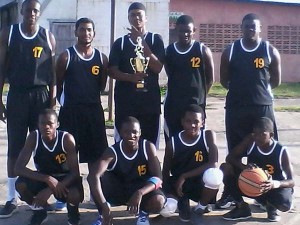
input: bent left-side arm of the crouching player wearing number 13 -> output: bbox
[14,132,48,182]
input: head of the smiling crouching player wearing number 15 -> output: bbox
[120,116,141,149]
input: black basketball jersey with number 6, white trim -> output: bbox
[60,46,104,106]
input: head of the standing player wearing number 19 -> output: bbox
[241,13,261,40]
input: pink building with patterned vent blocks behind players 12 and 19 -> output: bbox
[169,0,300,82]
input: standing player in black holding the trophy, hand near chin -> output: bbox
[109,2,165,149]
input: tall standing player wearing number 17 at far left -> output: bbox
[0,0,56,218]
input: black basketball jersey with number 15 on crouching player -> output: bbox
[108,139,150,185]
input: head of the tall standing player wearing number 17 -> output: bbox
[21,0,41,25]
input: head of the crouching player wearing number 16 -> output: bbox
[181,104,205,136]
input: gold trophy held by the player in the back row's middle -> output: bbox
[130,37,150,92]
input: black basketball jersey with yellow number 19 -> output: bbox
[226,39,273,106]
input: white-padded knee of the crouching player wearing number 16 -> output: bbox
[203,168,223,190]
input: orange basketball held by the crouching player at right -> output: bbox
[238,168,268,197]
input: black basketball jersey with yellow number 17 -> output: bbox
[6,24,53,89]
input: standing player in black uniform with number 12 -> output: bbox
[164,15,214,139]
